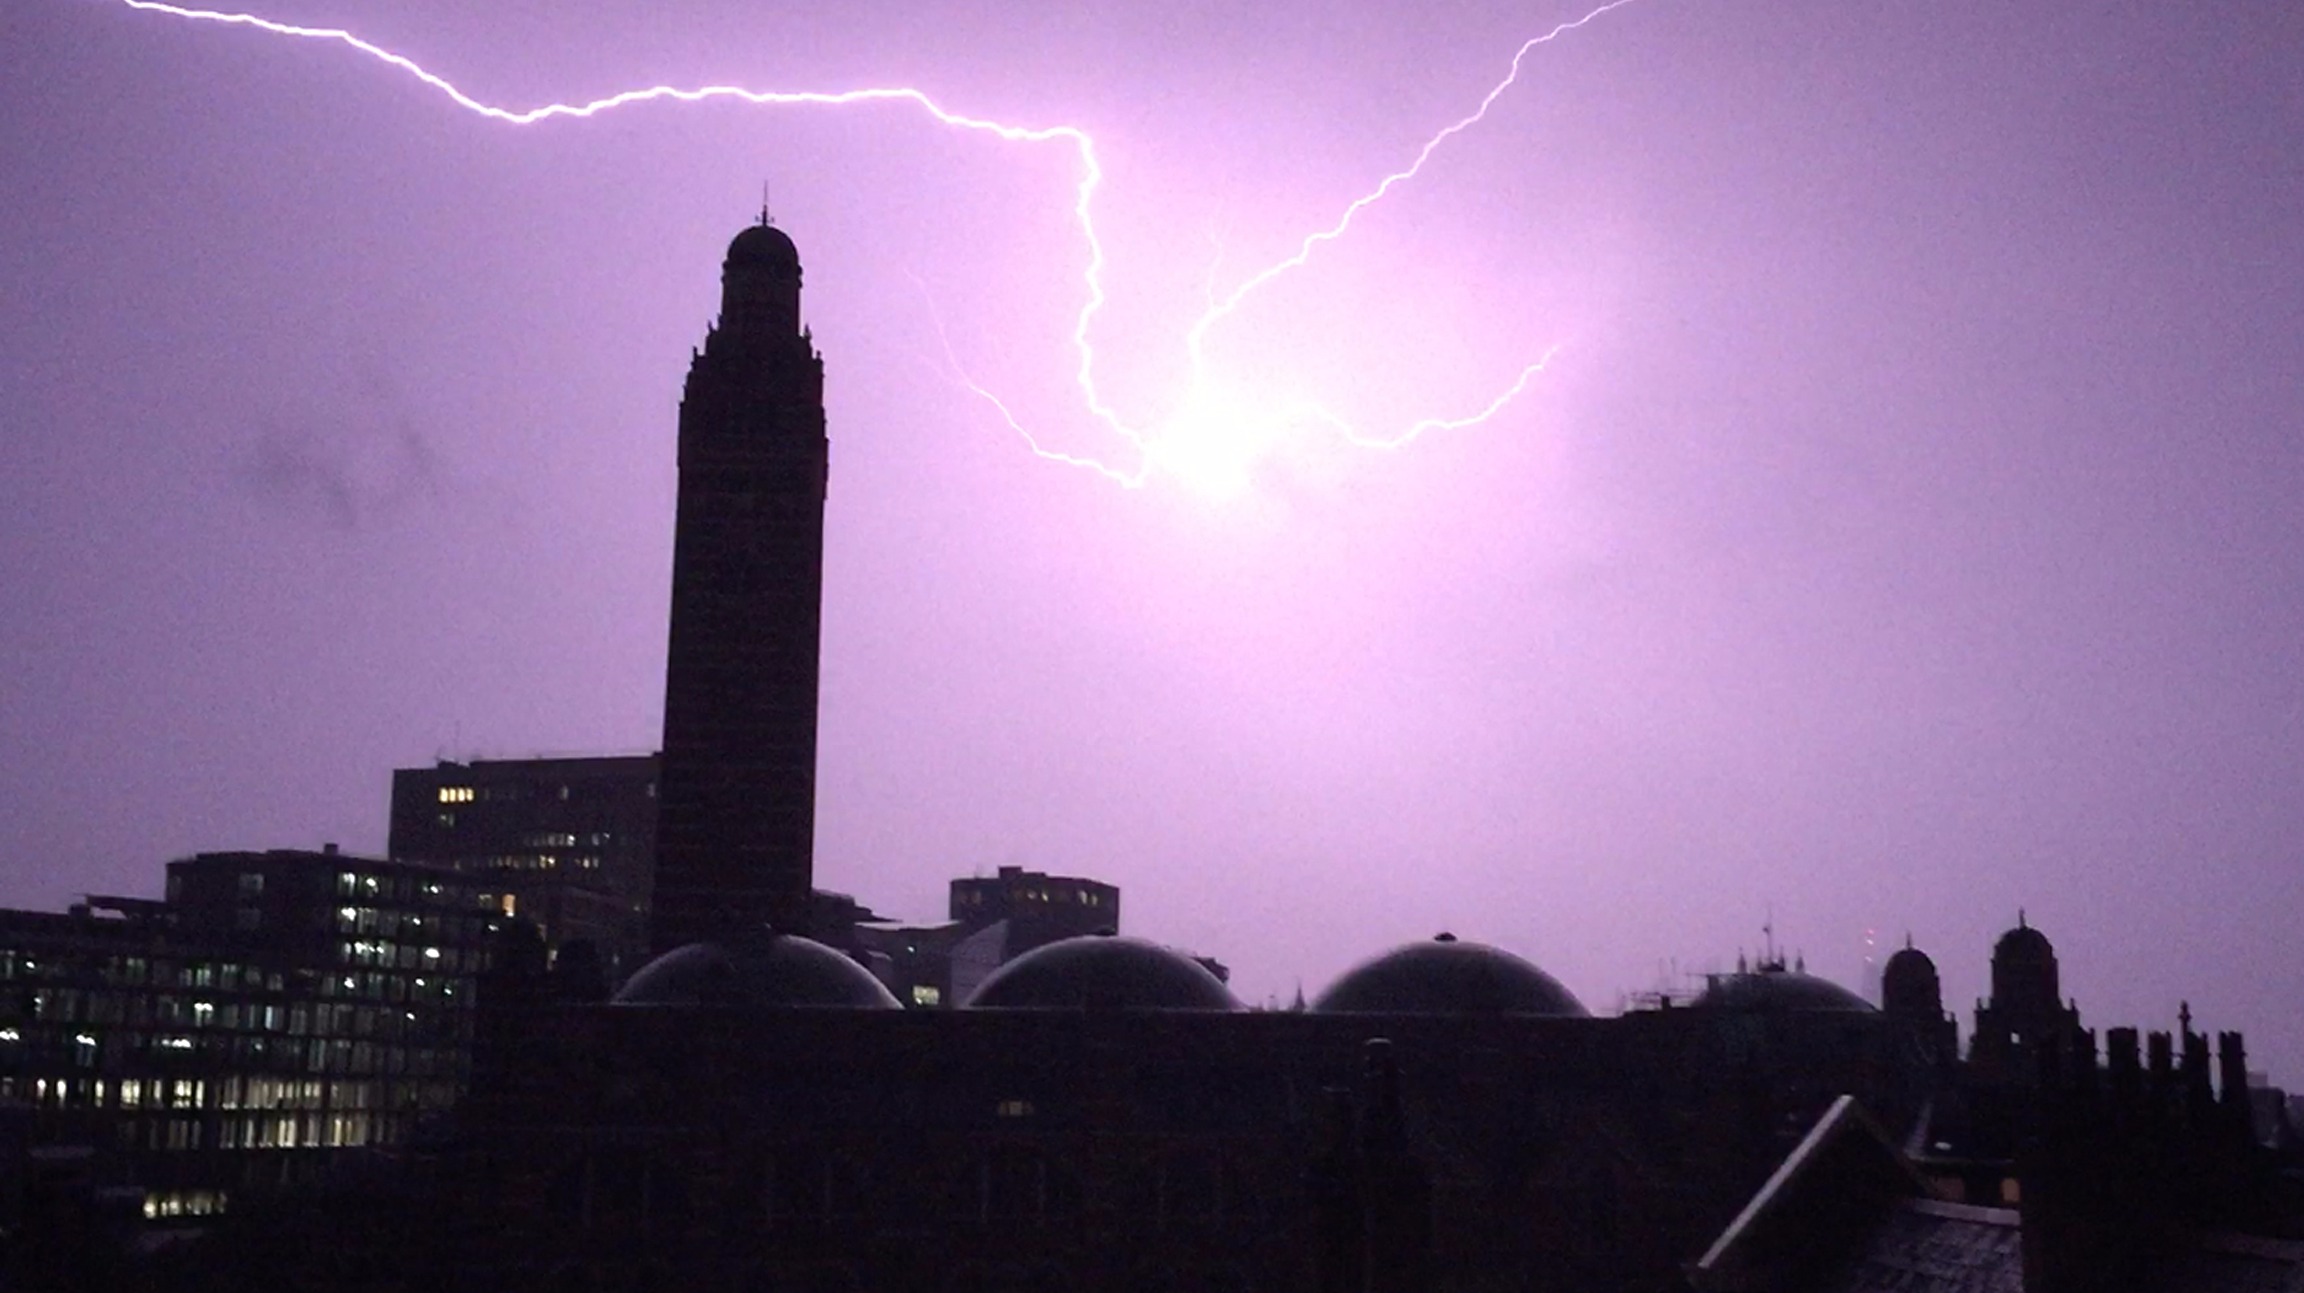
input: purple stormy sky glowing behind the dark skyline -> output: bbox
[0,0,2304,1083]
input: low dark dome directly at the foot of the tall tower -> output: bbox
[615,931,901,1010]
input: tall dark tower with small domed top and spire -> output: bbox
[650,214,829,952]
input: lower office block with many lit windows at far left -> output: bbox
[0,850,500,1219]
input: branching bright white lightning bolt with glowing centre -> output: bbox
[120,0,1634,493]
